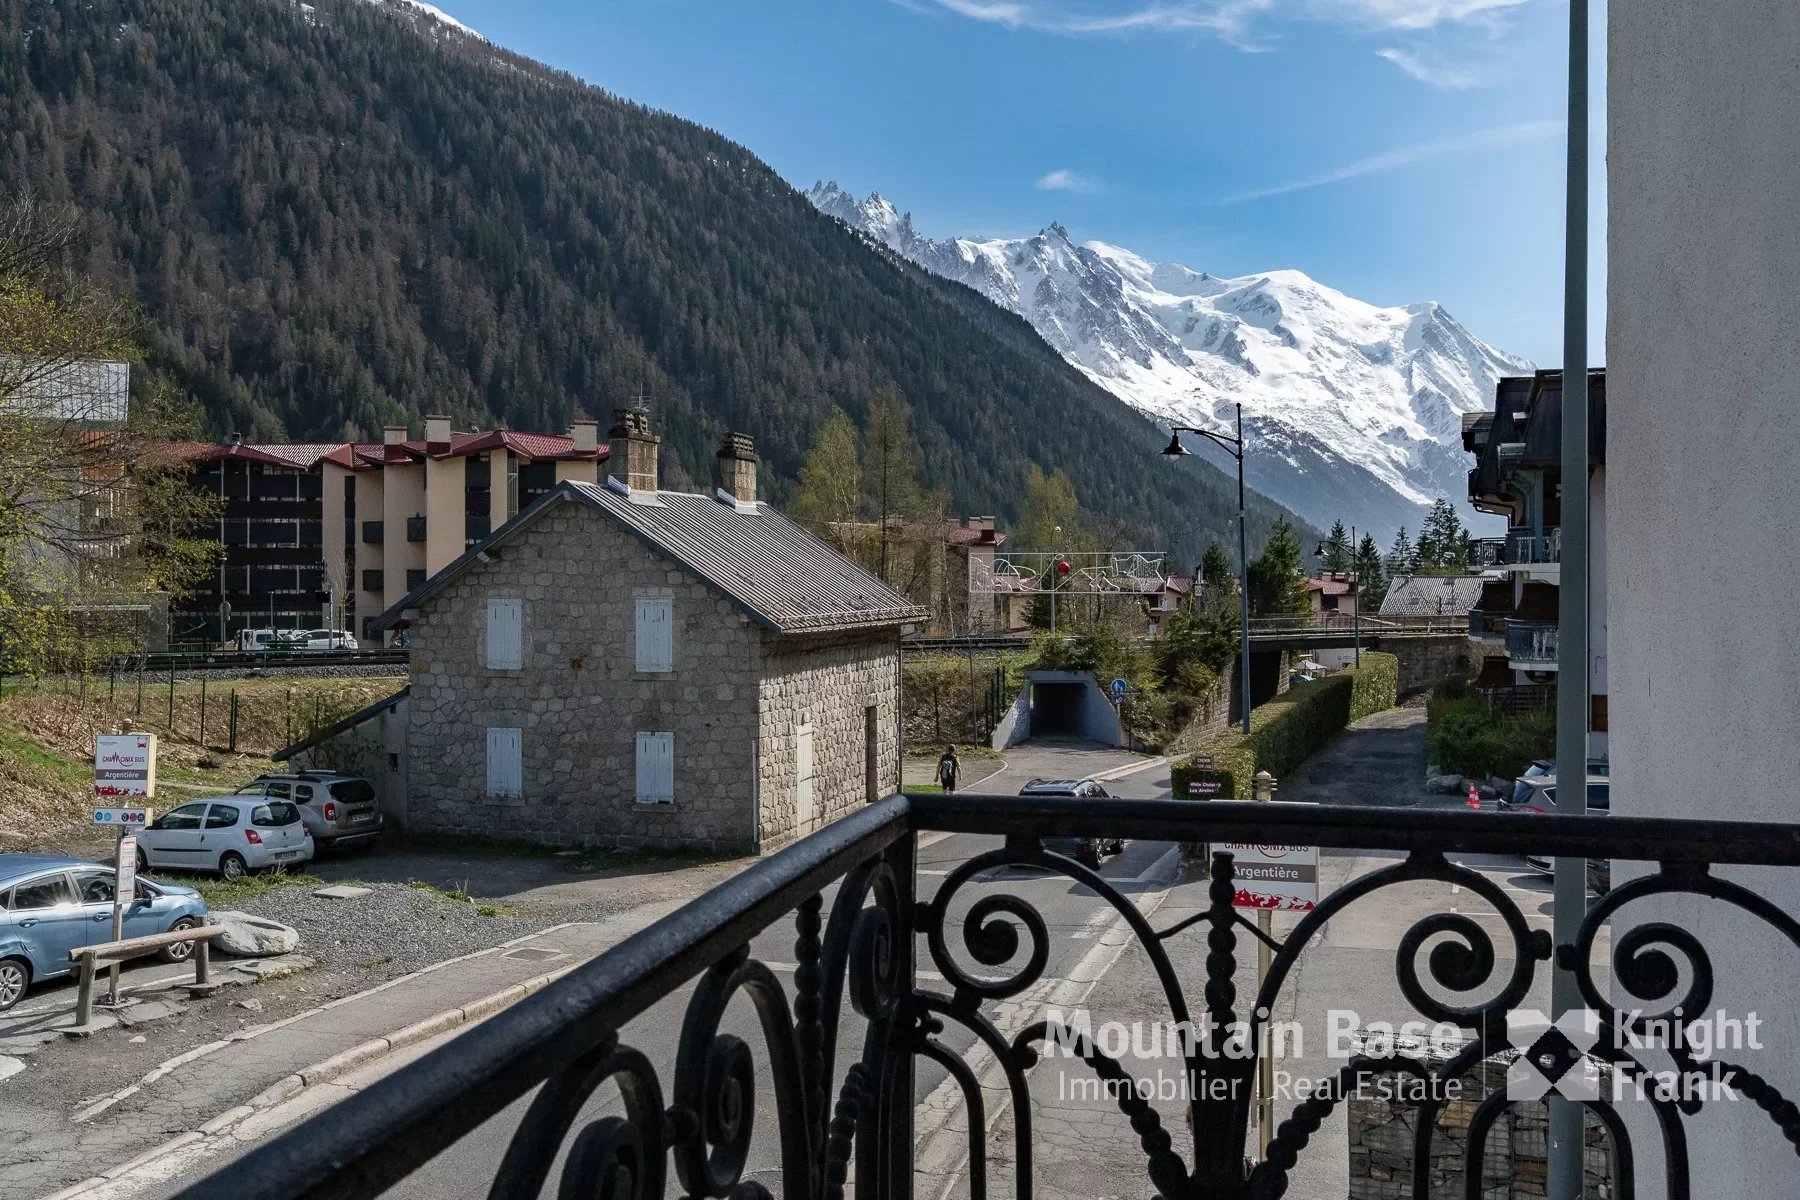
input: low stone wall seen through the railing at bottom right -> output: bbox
[1348,1054,1618,1200]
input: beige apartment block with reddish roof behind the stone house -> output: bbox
[320,416,607,637]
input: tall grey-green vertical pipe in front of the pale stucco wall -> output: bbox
[1546,0,1588,1200]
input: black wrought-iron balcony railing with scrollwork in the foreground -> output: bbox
[180,795,1800,1200]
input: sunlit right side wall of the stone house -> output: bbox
[756,630,900,849]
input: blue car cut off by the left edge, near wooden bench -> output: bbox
[0,855,207,1013]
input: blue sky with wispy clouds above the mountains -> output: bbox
[441,0,1606,363]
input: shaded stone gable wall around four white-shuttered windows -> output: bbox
[409,504,766,853]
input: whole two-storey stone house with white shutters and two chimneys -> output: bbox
[376,410,925,853]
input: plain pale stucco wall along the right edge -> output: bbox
[1606,0,1800,1200]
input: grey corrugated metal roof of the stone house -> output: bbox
[374,482,927,633]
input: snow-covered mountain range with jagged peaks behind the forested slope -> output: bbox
[806,184,1532,536]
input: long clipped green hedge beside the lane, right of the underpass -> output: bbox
[1170,651,1400,801]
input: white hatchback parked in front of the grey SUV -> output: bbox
[137,795,313,880]
